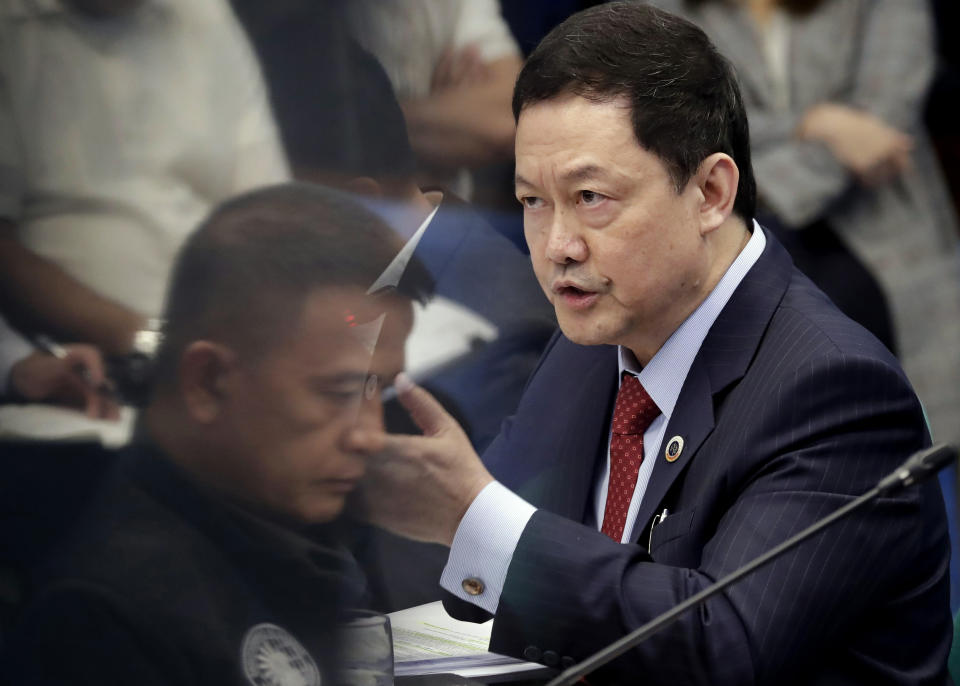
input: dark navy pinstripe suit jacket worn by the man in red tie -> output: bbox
[456,235,951,686]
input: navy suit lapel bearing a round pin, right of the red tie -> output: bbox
[631,233,793,542]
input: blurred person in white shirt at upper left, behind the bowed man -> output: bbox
[0,0,287,362]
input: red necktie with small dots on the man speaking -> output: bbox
[600,372,660,543]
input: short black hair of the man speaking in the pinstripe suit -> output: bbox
[513,1,757,222]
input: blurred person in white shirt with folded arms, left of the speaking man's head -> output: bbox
[344,0,521,207]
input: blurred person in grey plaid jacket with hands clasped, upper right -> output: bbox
[651,0,960,448]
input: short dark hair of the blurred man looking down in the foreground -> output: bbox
[156,182,430,386]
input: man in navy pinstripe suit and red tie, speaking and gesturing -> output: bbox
[351,2,951,685]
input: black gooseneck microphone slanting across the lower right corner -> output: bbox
[546,443,958,686]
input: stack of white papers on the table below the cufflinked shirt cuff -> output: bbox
[390,601,546,677]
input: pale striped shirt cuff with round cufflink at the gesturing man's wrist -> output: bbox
[440,481,537,614]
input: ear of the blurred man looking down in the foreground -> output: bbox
[178,341,237,424]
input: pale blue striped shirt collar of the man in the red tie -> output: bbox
[618,221,767,420]
